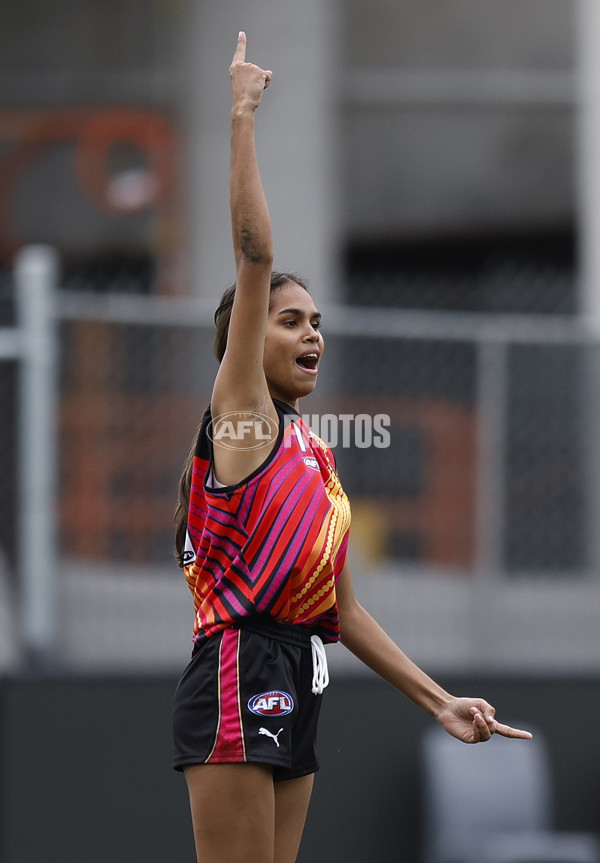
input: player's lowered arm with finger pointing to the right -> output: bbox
[337,563,532,743]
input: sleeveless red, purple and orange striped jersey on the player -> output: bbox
[184,401,350,642]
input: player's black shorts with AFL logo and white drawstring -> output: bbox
[173,618,322,780]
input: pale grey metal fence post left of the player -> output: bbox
[15,246,58,664]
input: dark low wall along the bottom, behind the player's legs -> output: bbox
[0,676,600,863]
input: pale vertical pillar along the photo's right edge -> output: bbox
[576,0,600,577]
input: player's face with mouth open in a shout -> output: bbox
[264,282,323,407]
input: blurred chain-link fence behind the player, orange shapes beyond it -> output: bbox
[0,250,600,670]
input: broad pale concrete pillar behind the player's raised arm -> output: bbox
[184,0,342,305]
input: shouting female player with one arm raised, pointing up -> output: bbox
[174,33,531,863]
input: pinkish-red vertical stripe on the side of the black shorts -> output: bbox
[208,627,246,763]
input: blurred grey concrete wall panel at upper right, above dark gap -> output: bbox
[341,0,577,238]
